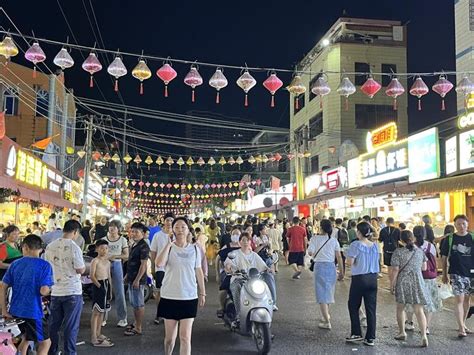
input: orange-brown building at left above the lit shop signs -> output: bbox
[0,62,76,175]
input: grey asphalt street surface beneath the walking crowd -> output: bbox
[78,265,474,355]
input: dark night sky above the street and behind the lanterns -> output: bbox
[1,0,455,147]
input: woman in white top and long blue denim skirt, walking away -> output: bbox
[308,219,344,329]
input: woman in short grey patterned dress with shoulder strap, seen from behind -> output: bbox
[391,230,428,347]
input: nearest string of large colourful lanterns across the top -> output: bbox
[0,35,474,110]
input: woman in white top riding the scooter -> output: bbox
[224,232,276,327]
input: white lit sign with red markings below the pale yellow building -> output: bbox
[304,166,348,197]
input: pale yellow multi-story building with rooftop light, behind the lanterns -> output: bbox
[290,18,408,179]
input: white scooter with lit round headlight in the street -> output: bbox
[223,253,273,354]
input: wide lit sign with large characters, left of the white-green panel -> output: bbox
[360,140,408,185]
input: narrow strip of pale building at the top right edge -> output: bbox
[454,0,474,111]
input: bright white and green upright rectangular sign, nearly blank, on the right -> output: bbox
[408,127,440,183]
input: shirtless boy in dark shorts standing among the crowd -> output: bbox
[90,239,114,348]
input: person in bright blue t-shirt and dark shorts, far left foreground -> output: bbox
[0,234,53,355]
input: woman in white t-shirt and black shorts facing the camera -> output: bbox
[155,217,206,355]
